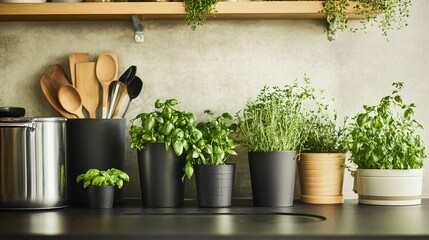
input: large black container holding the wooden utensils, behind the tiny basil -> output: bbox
[66,119,126,204]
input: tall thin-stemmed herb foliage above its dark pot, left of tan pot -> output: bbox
[237,77,315,152]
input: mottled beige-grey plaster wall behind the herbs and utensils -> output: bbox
[0,1,429,198]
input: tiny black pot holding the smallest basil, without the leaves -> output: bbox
[87,186,115,208]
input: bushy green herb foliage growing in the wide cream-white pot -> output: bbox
[346,82,426,169]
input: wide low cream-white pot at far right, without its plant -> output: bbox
[355,169,423,205]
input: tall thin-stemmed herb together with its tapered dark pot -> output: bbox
[237,78,313,207]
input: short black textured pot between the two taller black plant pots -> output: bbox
[195,164,235,207]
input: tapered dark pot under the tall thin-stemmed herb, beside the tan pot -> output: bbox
[248,151,296,207]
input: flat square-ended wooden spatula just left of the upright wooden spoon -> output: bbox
[76,62,100,118]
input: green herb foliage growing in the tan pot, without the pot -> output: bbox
[302,91,347,153]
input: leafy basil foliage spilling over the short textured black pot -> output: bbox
[183,110,237,179]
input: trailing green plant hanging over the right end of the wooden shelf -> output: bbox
[323,0,411,40]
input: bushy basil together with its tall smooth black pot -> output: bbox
[129,99,201,207]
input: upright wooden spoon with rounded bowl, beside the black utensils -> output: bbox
[95,53,118,118]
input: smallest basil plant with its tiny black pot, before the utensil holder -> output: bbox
[76,168,130,208]
